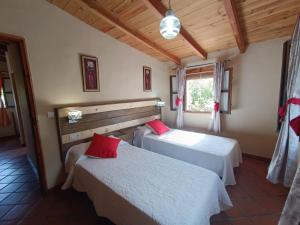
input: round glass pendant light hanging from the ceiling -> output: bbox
[160,0,180,40]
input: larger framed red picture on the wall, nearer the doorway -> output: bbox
[80,55,100,92]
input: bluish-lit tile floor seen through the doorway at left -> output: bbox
[0,145,41,225]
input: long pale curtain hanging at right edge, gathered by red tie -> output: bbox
[267,19,300,187]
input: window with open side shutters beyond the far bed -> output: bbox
[170,65,232,113]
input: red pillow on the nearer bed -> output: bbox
[85,133,121,158]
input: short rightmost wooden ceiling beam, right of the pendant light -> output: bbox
[224,0,247,53]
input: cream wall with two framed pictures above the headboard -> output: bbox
[0,0,169,188]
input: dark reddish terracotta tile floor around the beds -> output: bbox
[22,158,288,225]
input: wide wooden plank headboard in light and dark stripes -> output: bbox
[55,98,161,161]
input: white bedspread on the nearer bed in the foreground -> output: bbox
[65,142,232,225]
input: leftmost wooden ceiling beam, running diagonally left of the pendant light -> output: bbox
[76,0,180,65]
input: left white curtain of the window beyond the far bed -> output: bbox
[176,68,186,128]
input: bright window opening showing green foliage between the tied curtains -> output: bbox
[186,77,214,112]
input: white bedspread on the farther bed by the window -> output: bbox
[134,127,242,185]
